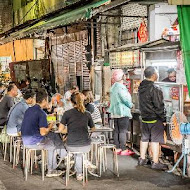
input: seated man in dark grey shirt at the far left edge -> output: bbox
[0,83,18,126]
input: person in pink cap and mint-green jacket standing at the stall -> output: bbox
[109,69,133,156]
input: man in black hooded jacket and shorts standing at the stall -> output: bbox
[138,66,167,170]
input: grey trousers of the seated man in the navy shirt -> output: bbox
[26,137,67,171]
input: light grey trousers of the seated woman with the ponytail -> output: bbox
[67,145,91,175]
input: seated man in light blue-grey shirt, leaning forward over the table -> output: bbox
[7,90,35,135]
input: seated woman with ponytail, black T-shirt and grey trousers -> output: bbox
[59,92,95,180]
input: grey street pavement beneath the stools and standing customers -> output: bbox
[0,152,190,190]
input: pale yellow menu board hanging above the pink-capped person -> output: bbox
[109,50,140,67]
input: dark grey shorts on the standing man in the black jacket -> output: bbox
[141,120,164,144]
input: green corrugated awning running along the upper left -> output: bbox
[7,0,111,39]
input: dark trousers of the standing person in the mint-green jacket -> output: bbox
[114,117,129,151]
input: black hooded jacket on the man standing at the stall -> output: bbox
[138,79,166,122]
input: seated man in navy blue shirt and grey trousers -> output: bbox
[21,89,66,177]
